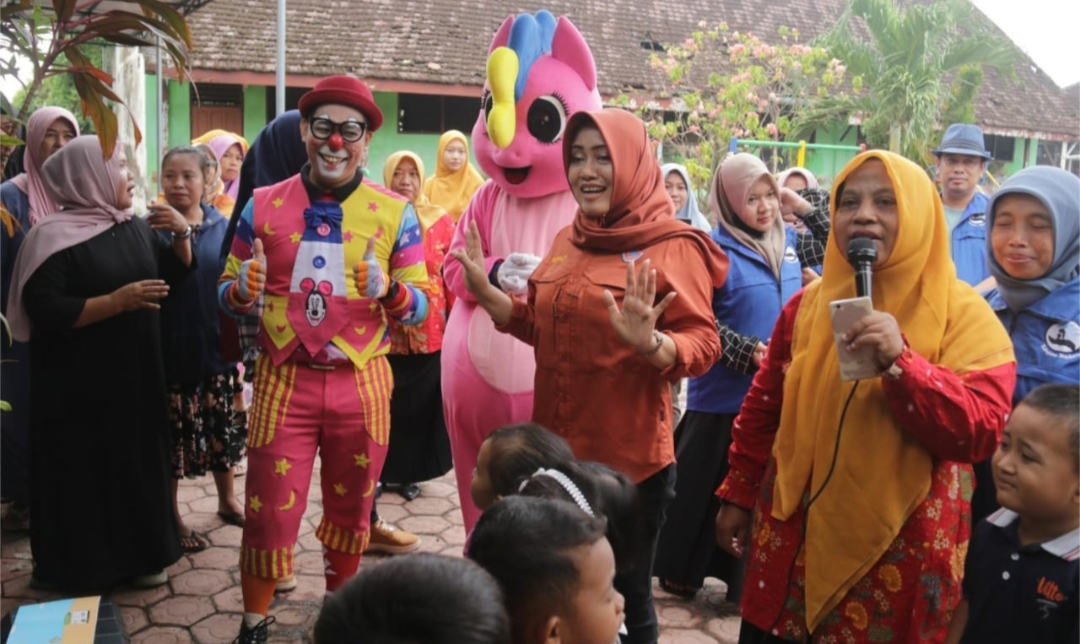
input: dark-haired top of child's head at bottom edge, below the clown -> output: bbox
[314,553,511,644]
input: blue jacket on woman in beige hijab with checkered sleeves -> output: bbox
[686,226,802,414]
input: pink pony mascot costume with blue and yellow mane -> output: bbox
[442,11,602,532]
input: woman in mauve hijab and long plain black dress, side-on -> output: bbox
[8,136,191,594]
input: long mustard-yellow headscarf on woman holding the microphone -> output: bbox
[772,151,1014,631]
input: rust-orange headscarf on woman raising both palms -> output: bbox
[563,108,728,287]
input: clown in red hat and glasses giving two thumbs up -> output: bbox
[218,76,428,644]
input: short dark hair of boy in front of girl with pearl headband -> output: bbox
[470,496,606,644]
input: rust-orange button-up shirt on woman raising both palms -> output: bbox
[500,228,720,482]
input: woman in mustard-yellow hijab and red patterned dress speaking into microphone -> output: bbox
[716,151,1016,644]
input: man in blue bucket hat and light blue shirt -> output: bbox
[931,123,993,291]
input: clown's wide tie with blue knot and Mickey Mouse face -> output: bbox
[287,201,349,354]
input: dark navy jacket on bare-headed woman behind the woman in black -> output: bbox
[161,205,235,385]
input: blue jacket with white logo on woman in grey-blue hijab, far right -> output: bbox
[986,278,1080,406]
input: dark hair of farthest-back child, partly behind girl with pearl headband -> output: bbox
[487,422,573,496]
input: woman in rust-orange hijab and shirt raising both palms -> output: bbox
[454,109,728,644]
